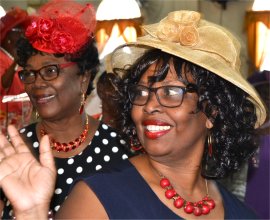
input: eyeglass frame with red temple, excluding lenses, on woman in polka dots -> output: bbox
[18,62,76,84]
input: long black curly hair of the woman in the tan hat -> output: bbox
[114,49,257,179]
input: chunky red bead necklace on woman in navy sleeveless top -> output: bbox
[160,175,215,216]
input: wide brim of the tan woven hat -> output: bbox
[110,42,266,128]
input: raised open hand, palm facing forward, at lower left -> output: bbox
[0,125,56,219]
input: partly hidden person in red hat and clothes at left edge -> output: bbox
[0,7,32,134]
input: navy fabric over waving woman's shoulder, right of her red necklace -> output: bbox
[216,182,258,219]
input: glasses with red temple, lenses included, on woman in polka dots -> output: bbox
[18,62,76,84]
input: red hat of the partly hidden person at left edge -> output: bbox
[0,7,28,43]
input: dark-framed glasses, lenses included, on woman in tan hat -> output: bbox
[128,84,197,108]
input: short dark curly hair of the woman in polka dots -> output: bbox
[16,37,100,95]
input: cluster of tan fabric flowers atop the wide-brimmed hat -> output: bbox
[157,11,200,46]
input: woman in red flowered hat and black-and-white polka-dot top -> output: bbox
[0,0,133,219]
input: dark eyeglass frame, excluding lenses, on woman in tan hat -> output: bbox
[128,83,198,108]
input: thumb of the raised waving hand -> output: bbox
[39,135,55,173]
